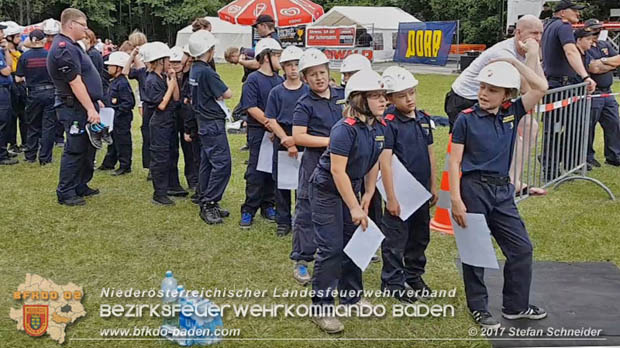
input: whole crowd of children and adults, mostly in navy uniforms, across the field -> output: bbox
[0,0,620,333]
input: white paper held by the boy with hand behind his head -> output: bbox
[450,213,499,269]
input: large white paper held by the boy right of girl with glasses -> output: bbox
[377,155,433,221]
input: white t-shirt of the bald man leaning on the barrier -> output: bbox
[452,38,525,100]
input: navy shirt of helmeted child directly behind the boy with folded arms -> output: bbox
[265,83,310,128]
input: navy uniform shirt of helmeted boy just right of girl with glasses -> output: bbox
[384,108,433,190]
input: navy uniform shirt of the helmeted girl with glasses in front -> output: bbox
[313,117,386,188]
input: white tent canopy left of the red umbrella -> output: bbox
[175,17,252,62]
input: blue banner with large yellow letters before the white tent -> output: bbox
[394,22,456,65]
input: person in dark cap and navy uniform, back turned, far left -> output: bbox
[15,29,56,165]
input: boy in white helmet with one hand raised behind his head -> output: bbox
[448,58,548,328]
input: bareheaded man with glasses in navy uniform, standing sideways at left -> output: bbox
[47,8,104,206]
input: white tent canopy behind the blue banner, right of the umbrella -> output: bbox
[311,6,419,61]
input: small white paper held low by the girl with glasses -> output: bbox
[344,219,385,272]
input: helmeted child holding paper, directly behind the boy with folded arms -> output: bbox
[265,46,309,237]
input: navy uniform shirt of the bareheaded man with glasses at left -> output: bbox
[47,34,103,102]
